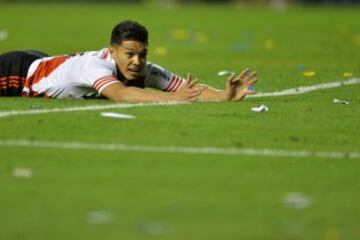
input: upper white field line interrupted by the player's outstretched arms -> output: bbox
[0,78,360,118]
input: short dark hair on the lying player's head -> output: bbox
[110,20,148,46]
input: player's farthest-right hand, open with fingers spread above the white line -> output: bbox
[225,68,257,101]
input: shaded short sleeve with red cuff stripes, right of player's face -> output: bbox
[145,62,185,92]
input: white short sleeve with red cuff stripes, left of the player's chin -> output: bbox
[83,57,119,93]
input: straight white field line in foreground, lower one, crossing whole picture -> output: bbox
[0,140,360,159]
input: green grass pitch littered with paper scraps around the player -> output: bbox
[0,4,360,240]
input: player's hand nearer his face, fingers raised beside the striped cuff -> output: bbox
[174,73,201,101]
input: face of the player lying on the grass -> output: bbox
[110,41,147,80]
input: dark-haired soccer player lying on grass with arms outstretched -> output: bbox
[0,21,256,102]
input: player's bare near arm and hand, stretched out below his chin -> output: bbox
[101,78,201,102]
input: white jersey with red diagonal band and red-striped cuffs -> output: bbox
[23,48,184,98]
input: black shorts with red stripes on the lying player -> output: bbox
[0,51,49,96]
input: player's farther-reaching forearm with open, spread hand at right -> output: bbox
[194,68,257,101]
